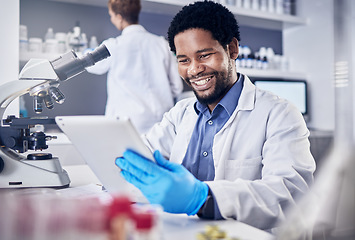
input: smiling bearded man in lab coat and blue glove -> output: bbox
[116,1,315,230]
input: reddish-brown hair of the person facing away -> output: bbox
[108,0,142,24]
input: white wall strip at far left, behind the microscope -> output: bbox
[0,0,20,115]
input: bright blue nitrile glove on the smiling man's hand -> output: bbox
[116,150,208,215]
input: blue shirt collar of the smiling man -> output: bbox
[194,74,244,116]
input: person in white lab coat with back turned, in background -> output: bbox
[87,0,183,133]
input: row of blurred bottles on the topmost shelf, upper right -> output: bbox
[221,0,295,15]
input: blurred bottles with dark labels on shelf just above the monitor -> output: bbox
[235,46,289,71]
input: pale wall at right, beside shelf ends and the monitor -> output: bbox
[283,0,335,130]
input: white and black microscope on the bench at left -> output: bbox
[0,45,110,189]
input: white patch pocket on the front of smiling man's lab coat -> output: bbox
[225,156,262,181]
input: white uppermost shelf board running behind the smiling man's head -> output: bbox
[49,0,307,30]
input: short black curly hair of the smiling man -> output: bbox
[168,1,240,53]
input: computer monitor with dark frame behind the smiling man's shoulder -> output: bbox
[254,80,308,116]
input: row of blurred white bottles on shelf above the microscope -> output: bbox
[20,24,98,54]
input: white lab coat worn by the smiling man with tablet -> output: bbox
[144,76,315,229]
